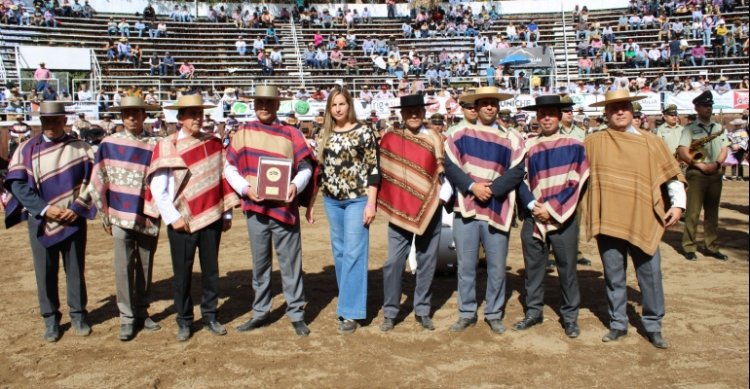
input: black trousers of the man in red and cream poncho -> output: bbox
[167,220,223,326]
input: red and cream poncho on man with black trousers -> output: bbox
[144,133,239,232]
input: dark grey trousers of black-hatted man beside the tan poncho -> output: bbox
[521,216,581,323]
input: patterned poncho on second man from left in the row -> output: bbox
[91,131,159,236]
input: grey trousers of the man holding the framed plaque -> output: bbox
[245,212,305,322]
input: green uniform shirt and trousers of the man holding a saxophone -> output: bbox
[679,120,729,253]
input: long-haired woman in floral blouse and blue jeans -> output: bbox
[308,86,380,334]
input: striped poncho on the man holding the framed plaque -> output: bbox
[227,121,317,224]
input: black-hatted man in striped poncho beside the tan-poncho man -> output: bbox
[513,95,589,338]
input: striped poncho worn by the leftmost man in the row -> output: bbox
[4,135,96,247]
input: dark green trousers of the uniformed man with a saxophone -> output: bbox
[682,169,723,253]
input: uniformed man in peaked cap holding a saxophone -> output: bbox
[677,91,729,261]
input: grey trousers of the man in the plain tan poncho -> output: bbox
[596,235,665,332]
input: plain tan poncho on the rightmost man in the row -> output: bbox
[581,129,685,255]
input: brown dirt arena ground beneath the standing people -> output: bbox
[0,182,748,388]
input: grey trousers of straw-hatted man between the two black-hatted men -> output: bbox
[453,215,508,320]
